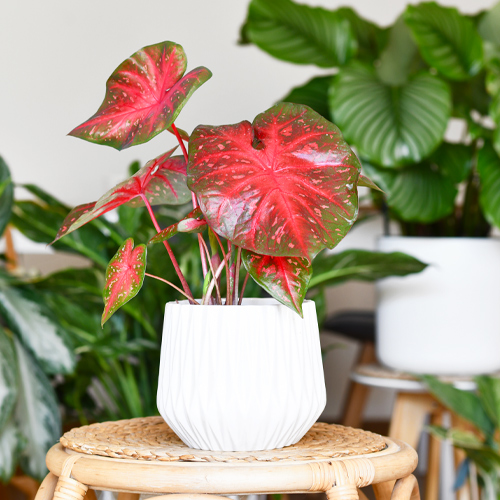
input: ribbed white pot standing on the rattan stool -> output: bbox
[157,299,326,451]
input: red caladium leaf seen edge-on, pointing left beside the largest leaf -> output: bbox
[54,148,191,241]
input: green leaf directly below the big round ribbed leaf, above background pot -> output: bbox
[363,162,457,224]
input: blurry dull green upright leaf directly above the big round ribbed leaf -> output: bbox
[376,17,418,85]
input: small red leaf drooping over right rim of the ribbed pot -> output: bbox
[241,250,312,316]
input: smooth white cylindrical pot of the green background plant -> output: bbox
[376,237,500,375]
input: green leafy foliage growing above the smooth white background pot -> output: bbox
[240,0,500,236]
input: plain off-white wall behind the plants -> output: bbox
[0,0,495,419]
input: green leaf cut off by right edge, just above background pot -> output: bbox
[477,141,500,227]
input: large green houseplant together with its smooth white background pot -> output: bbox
[242,0,500,373]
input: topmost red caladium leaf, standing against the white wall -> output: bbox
[69,42,212,150]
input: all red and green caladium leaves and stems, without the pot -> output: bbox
[56,42,373,323]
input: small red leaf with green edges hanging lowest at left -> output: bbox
[101,238,146,325]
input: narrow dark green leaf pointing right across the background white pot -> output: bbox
[309,250,427,290]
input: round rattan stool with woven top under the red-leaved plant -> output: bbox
[36,417,420,500]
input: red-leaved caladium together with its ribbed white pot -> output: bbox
[56,42,382,450]
